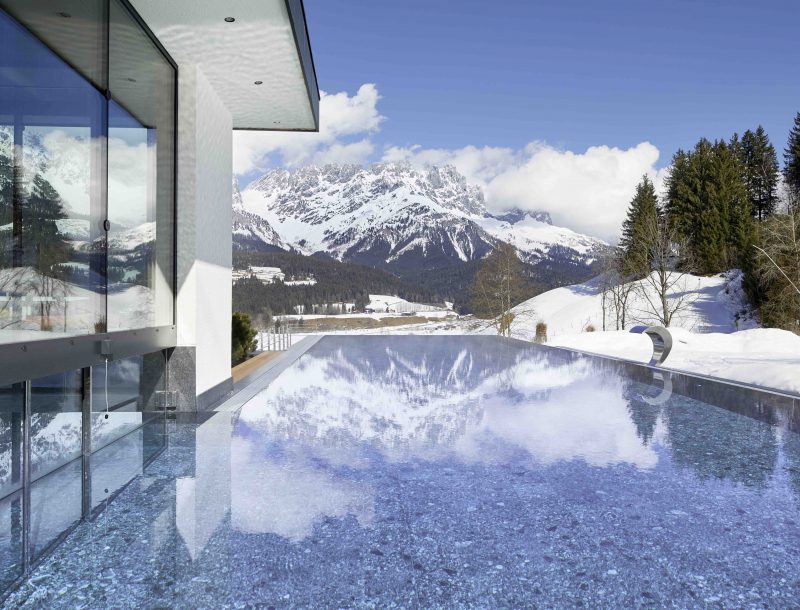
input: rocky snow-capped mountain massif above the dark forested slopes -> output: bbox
[234,163,605,273]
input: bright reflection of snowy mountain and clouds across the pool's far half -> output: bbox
[241,342,658,468]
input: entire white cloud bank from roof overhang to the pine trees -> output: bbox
[233,84,665,242]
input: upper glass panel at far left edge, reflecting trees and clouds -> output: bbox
[0,12,106,343]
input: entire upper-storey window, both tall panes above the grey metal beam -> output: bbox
[0,0,176,342]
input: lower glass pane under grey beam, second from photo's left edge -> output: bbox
[30,370,82,481]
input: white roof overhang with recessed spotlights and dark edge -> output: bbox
[129,0,319,131]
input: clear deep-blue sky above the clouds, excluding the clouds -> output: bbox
[306,0,800,165]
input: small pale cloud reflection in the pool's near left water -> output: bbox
[231,436,375,541]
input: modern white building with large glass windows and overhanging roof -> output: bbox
[0,0,319,590]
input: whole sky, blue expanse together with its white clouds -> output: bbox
[234,0,800,241]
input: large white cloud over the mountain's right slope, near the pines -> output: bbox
[383,142,664,241]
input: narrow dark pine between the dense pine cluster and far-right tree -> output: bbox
[731,125,779,222]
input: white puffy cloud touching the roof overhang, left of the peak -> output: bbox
[233,83,385,175]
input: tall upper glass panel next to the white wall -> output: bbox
[108,0,175,330]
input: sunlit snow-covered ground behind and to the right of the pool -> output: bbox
[288,272,800,394]
